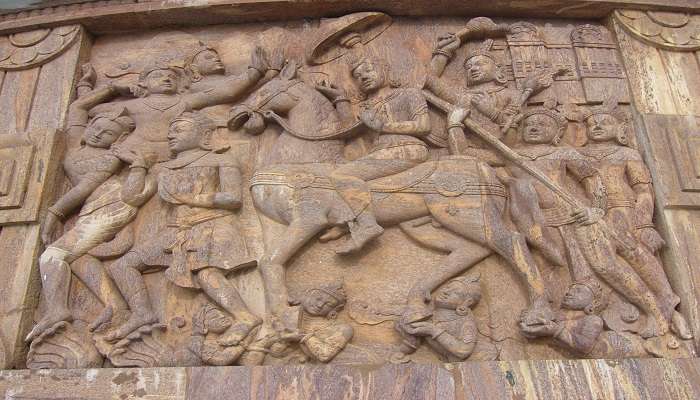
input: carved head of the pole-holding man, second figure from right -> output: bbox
[520,108,566,146]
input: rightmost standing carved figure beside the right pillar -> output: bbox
[579,104,691,339]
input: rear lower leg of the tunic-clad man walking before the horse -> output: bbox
[197,268,262,346]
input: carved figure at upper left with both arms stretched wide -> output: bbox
[92,47,279,161]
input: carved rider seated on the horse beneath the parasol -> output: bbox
[322,57,430,254]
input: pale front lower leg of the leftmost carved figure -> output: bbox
[24,247,73,342]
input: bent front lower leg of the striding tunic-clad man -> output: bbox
[105,251,158,341]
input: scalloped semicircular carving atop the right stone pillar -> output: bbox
[614,10,700,51]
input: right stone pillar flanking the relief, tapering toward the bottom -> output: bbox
[612,10,700,345]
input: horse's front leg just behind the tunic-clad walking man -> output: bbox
[258,217,329,328]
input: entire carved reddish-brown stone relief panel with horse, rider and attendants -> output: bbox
[26,12,695,368]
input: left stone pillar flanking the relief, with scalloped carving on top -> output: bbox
[0,25,87,368]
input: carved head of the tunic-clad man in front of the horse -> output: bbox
[168,111,216,156]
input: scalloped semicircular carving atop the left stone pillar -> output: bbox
[0,25,80,71]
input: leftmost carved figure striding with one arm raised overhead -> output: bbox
[26,78,155,341]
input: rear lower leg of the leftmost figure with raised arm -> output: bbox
[70,255,127,331]
